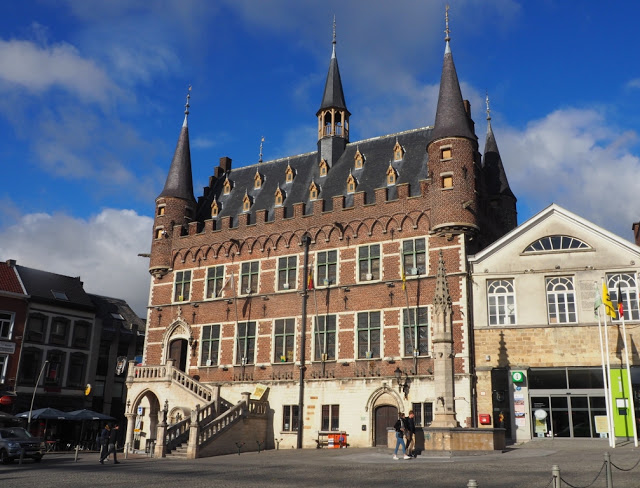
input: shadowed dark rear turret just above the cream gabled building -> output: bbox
[483,95,518,239]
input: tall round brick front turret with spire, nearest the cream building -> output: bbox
[427,7,480,235]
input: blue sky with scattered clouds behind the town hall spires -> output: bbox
[0,0,640,317]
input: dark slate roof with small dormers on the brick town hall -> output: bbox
[198,127,432,220]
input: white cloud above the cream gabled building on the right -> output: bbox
[494,108,640,240]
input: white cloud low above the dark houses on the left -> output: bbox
[0,209,153,318]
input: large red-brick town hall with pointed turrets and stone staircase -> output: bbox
[128,18,517,455]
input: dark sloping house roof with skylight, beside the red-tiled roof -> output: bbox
[16,265,94,310]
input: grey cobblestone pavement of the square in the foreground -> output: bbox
[0,439,640,488]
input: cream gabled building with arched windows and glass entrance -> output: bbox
[469,204,640,441]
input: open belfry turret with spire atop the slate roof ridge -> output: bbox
[316,18,351,167]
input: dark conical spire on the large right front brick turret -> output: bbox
[432,6,476,140]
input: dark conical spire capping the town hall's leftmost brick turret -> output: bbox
[158,86,195,202]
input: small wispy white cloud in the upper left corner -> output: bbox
[0,40,119,103]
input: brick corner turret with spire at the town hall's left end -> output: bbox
[149,87,196,277]
